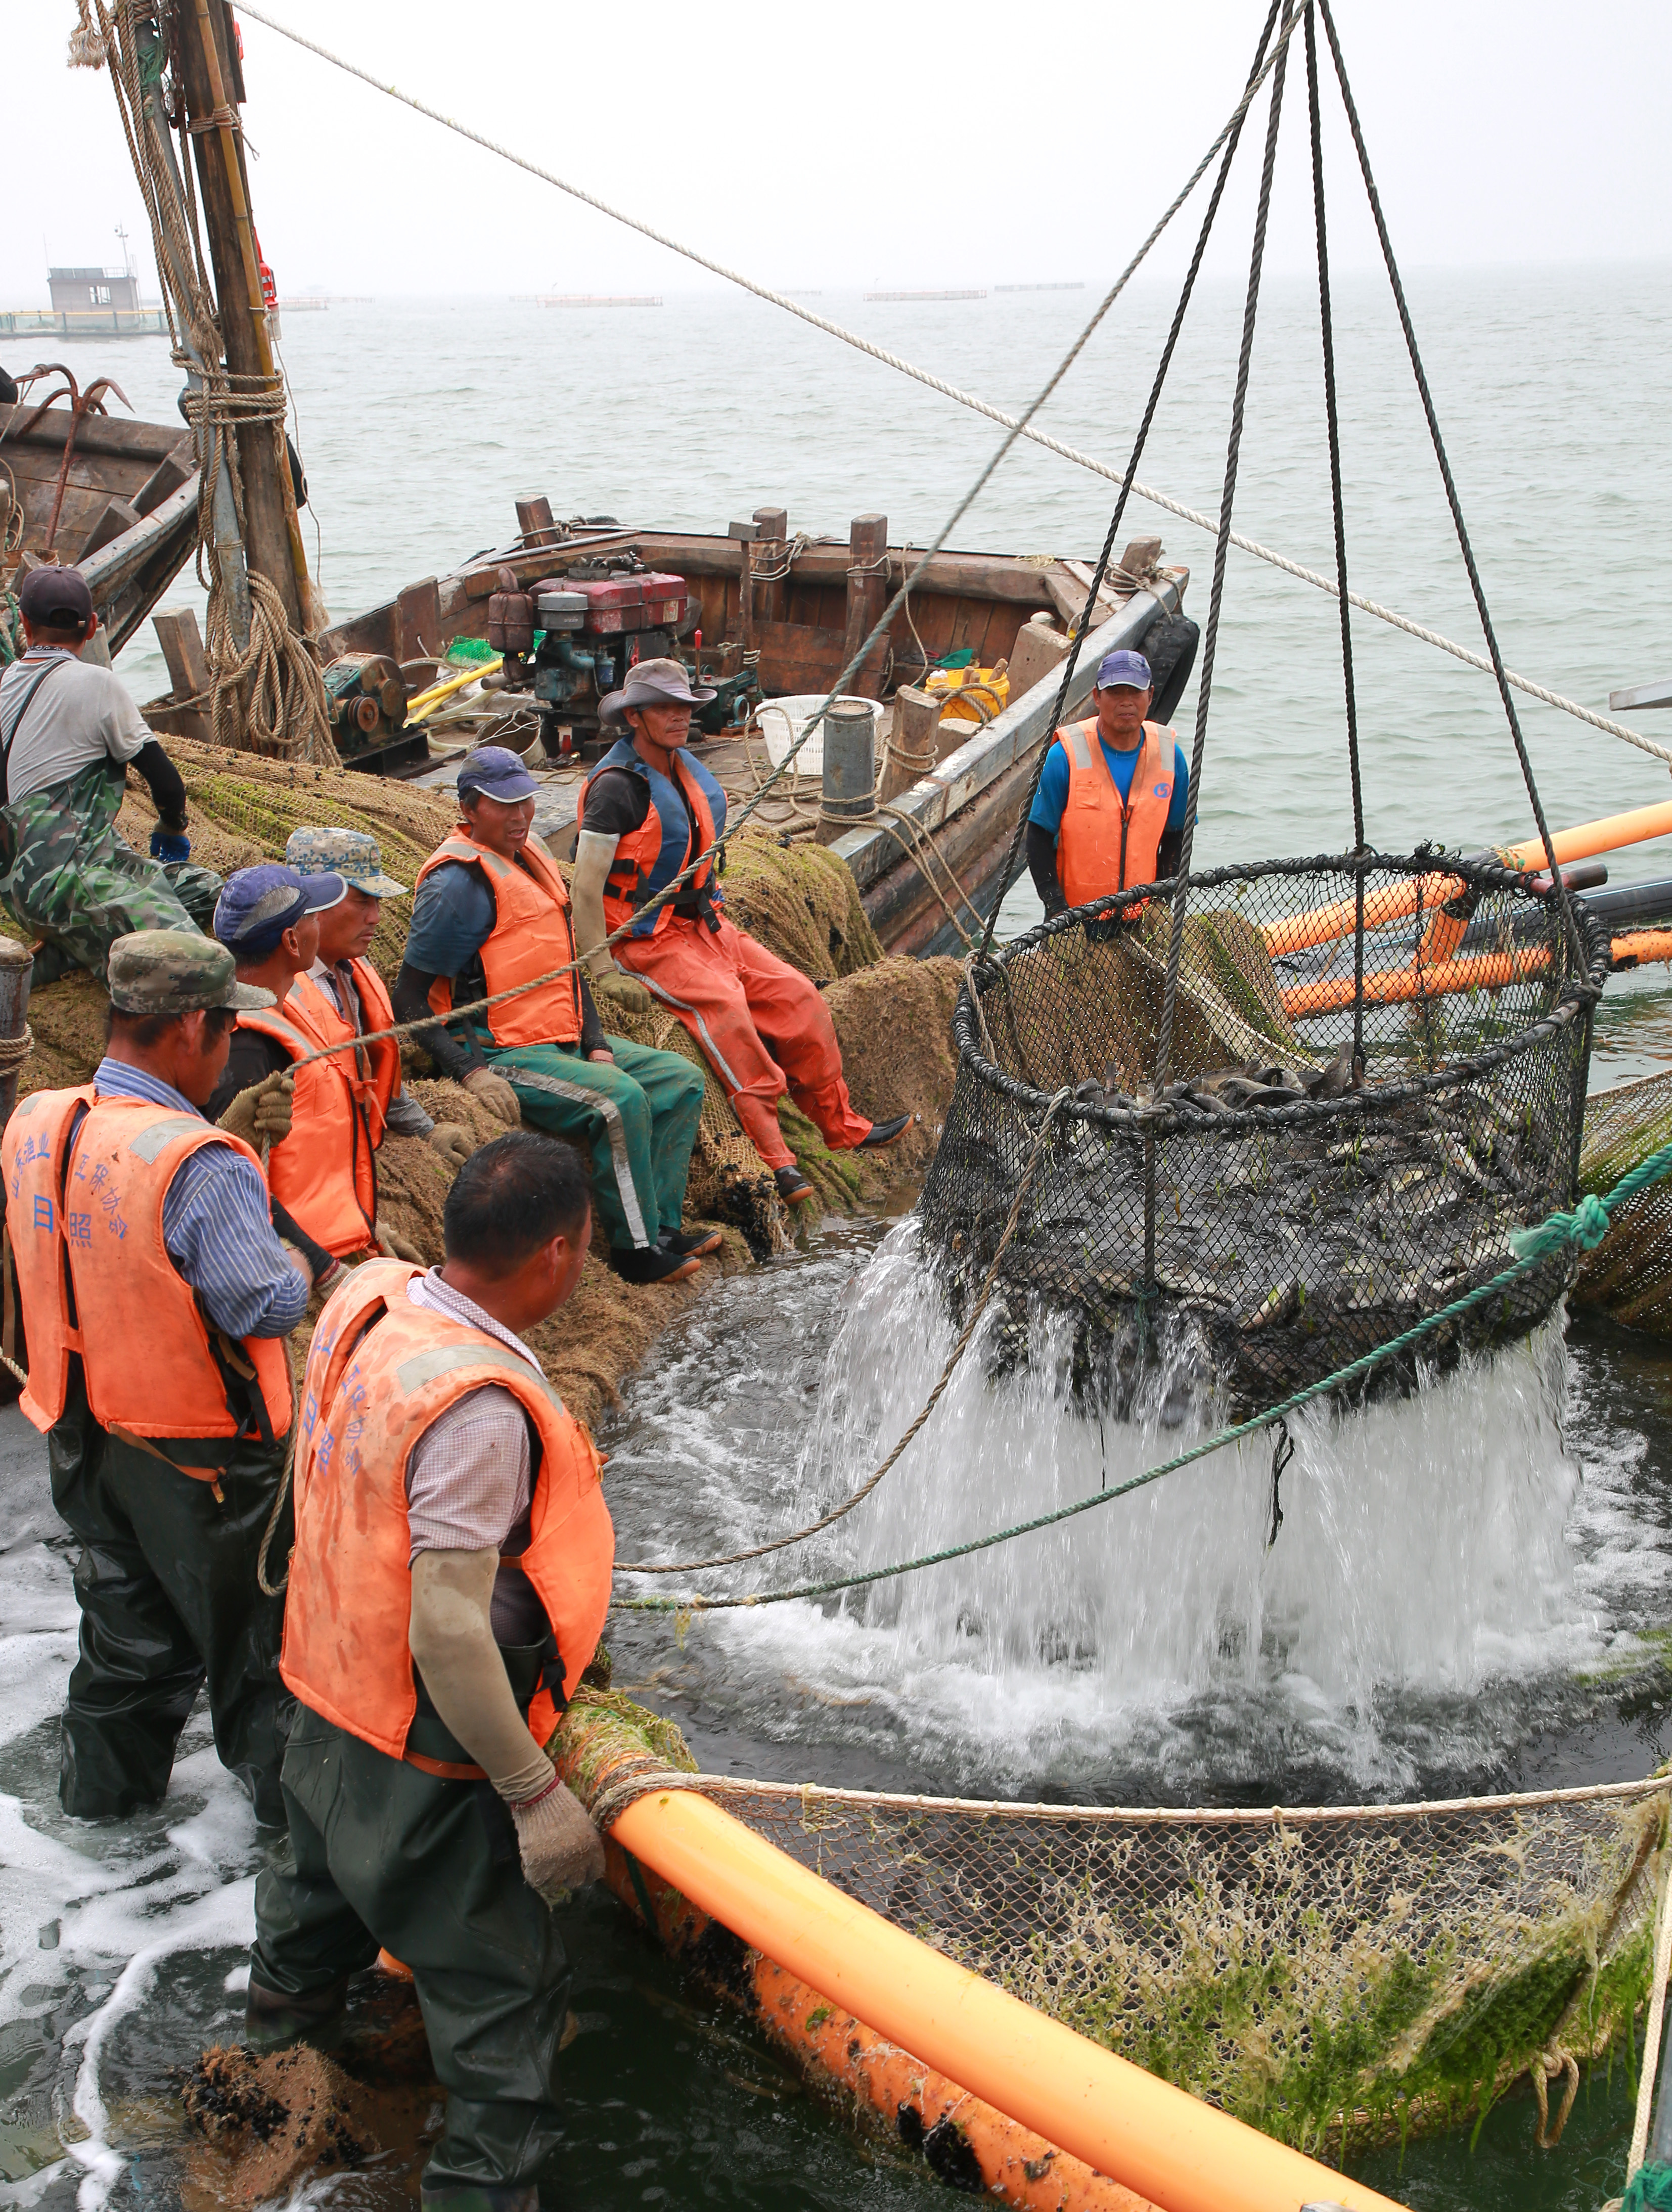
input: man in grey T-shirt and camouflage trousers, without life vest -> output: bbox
[0,568,221,984]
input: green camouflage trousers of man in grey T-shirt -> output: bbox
[0,761,221,975]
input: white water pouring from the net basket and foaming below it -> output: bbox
[613,1221,1667,1796]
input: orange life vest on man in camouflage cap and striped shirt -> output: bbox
[0,1086,290,1482]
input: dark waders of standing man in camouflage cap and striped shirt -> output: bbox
[47,1361,296,1827]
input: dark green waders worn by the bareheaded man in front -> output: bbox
[250,1690,571,2203]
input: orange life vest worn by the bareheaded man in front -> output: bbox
[279,1261,615,1758]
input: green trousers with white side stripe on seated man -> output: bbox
[486,1037,703,1252]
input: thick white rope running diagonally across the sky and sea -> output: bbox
[239,0,1672,768]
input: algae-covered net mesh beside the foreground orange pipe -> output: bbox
[701,1779,1667,2150]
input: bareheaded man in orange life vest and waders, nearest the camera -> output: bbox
[246,1131,615,2212]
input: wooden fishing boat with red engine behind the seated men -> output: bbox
[146,498,1197,954]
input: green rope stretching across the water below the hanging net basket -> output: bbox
[613,1144,1672,1619]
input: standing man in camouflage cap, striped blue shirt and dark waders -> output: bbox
[0,929,312,1825]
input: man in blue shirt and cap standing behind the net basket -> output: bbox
[1028,653,1190,920]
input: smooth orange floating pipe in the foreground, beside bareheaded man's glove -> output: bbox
[610,1789,1395,2212]
